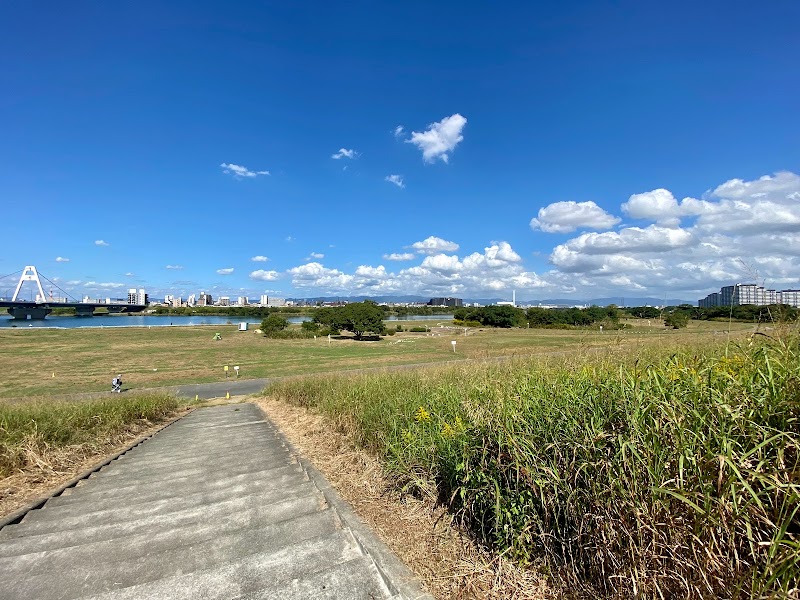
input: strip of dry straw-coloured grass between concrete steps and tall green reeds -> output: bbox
[256,398,559,600]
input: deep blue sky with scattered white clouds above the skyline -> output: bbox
[0,1,800,300]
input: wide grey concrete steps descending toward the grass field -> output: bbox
[0,404,430,600]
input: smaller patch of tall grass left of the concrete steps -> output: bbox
[0,394,185,477]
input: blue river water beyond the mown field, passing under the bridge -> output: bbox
[0,315,453,329]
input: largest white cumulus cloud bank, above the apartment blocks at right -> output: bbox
[536,171,800,298]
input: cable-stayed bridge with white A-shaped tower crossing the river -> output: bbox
[0,266,146,320]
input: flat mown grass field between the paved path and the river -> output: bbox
[0,319,753,398]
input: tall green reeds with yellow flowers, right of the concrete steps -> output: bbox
[269,333,800,598]
